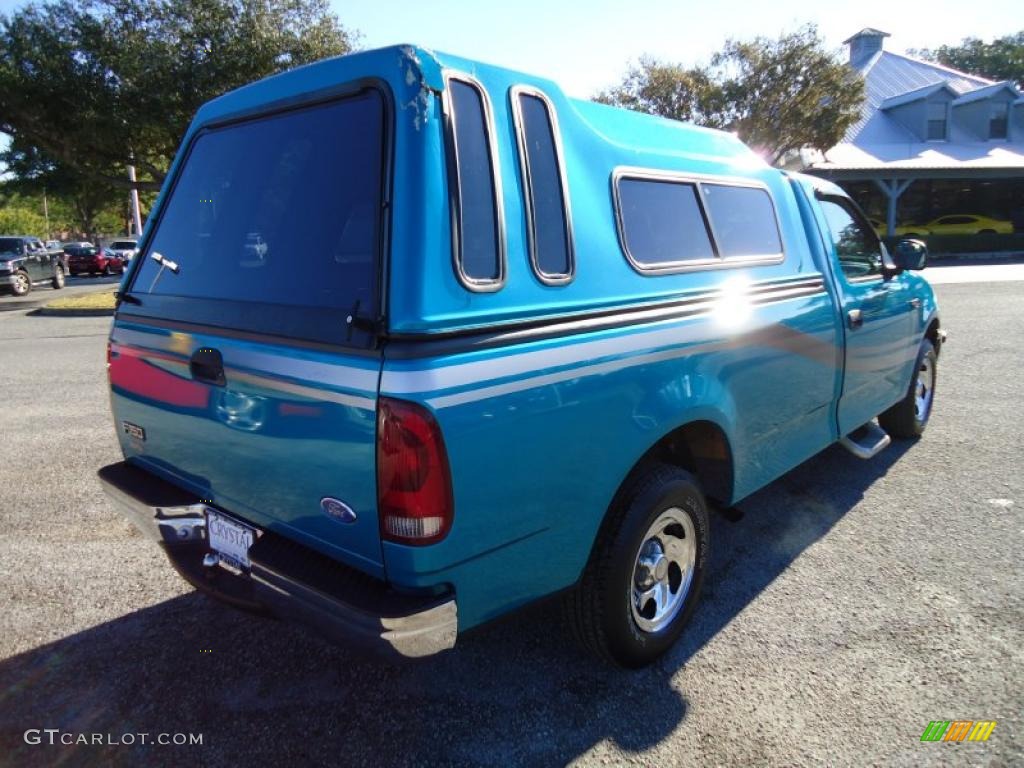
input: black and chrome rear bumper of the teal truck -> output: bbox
[98,462,458,657]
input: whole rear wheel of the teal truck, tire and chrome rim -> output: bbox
[566,464,709,668]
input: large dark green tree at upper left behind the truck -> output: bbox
[0,0,354,189]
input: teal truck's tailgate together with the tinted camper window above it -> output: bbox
[110,86,388,577]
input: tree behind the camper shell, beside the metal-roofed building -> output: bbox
[598,25,864,163]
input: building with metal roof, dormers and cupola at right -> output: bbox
[802,28,1024,240]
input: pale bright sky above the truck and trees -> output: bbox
[0,0,1024,160]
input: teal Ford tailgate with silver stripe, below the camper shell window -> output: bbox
[110,317,383,575]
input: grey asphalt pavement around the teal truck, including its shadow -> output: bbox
[0,274,1024,766]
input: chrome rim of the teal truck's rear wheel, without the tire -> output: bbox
[630,507,697,632]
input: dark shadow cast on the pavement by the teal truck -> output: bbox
[0,443,908,765]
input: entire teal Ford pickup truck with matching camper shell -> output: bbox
[99,47,943,667]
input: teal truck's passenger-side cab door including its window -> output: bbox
[817,194,916,434]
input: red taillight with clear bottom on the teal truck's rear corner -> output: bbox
[377,397,454,544]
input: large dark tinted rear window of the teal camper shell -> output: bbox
[132,90,384,315]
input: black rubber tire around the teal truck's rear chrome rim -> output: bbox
[565,464,710,669]
